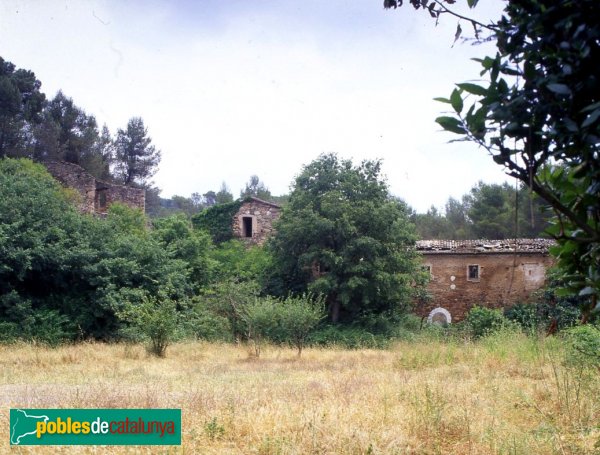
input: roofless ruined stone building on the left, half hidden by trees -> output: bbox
[44,161,146,215]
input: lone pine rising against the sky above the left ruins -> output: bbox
[115,117,161,188]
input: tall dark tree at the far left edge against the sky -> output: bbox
[0,57,46,158]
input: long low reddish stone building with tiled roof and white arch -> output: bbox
[417,239,554,323]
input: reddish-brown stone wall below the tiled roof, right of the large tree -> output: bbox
[417,252,553,322]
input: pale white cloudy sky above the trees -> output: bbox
[0,0,507,211]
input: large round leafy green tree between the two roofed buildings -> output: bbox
[269,154,419,322]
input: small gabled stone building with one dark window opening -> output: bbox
[232,197,281,245]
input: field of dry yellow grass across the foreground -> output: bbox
[0,334,600,454]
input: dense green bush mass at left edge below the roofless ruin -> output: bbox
[0,159,211,344]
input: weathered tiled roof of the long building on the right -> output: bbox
[417,239,555,254]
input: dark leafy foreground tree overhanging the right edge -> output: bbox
[437,0,600,321]
